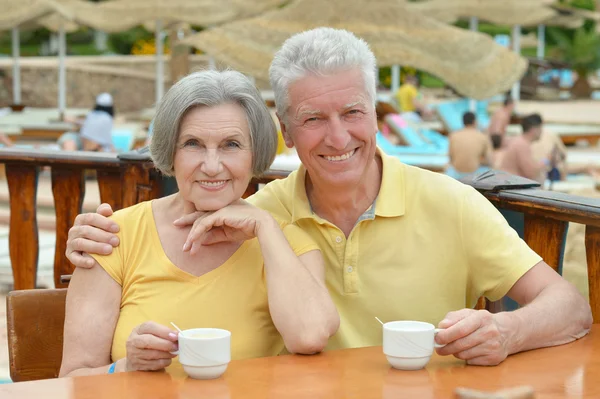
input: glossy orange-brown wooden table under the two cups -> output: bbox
[0,325,600,399]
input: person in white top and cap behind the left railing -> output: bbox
[58,93,115,152]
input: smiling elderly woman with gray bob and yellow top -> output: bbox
[60,71,339,376]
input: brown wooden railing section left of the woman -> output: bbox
[0,149,161,290]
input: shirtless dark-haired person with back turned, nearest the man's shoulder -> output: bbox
[446,112,492,179]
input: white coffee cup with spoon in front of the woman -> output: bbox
[173,328,231,380]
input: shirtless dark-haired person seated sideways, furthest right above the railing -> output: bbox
[498,114,558,182]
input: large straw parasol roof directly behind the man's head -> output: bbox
[183,0,527,99]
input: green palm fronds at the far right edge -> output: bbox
[548,28,600,76]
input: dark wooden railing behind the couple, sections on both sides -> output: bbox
[0,149,600,323]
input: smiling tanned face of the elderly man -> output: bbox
[280,68,377,191]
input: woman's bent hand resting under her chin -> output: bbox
[176,200,275,255]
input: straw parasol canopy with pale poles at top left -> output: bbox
[0,0,284,108]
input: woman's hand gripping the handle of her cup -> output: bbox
[125,321,178,371]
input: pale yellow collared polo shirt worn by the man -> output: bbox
[250,150,541,349]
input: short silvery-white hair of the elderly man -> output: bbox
[269,28,377,118]
